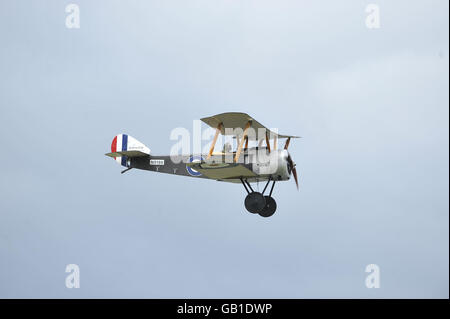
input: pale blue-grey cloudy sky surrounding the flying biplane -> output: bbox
[0,0,449,298]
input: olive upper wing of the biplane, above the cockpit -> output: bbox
[201,112,299,139]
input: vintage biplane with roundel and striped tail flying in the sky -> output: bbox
[105,112,298,217]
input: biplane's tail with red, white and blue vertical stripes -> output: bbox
[105,134,150,167]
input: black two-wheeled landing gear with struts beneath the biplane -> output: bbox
[241,177,277,217]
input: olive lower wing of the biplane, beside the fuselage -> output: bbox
[186,162,256,179]
